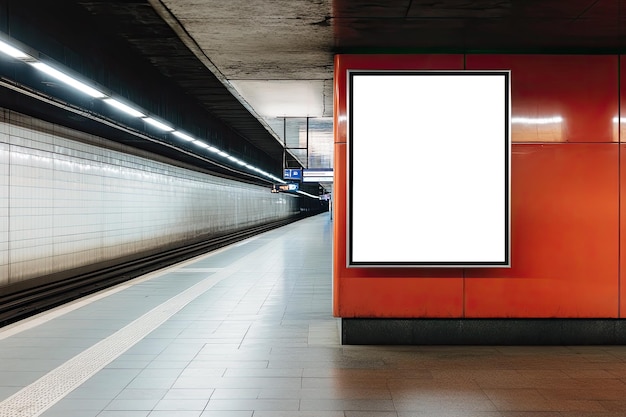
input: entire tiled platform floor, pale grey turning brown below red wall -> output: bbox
[0,214,626,417]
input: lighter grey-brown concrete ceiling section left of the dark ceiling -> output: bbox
[150,0,333,118]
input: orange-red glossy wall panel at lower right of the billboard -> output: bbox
[465,143,619,317]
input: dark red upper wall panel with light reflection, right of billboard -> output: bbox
[466,55,618,142]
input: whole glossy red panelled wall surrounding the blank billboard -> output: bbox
[334,55,626,318]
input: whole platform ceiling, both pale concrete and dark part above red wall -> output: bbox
[150,0,626,123]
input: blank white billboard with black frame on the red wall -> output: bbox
[348,71,510,267]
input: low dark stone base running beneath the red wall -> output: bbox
[341,318,626,345]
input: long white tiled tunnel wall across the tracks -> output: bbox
[0,110,298,285]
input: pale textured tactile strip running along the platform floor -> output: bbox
[0,237,273,417]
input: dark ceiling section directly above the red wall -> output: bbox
[332,0,626,53]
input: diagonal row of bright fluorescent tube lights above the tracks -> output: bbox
[0,35,285,184]
